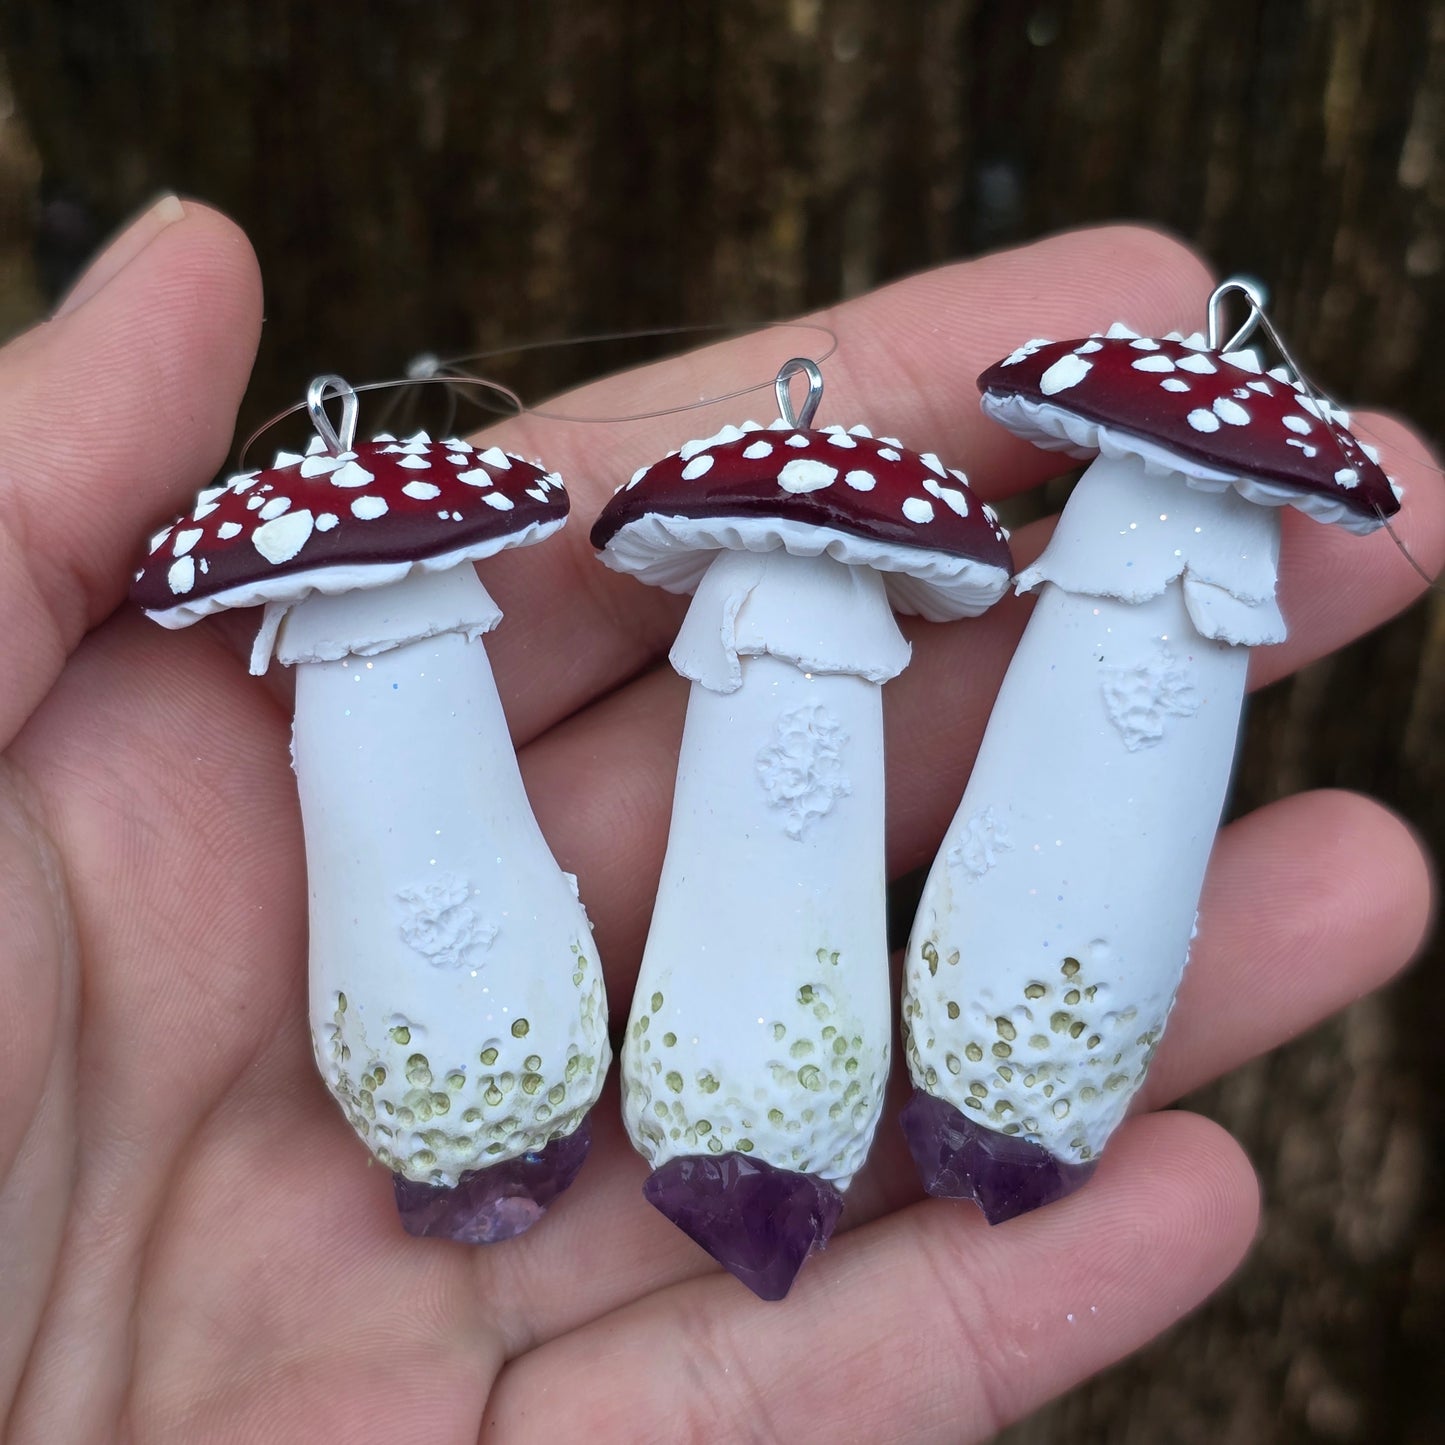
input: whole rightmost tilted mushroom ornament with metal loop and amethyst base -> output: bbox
[903,282,1399,1222]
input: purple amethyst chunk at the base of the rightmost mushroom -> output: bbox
[902,1090,1095,1224]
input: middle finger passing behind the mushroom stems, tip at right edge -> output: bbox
[522,447,1445,980]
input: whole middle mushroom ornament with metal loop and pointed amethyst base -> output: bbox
[592,361,1010,1299]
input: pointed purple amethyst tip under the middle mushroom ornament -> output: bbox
[642,1153,842,1299]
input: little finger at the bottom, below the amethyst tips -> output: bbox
[481,1114,1257,1445]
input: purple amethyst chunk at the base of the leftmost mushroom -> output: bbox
[392,1117,592,1244]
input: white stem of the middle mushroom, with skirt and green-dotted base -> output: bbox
[623,551,907,1188]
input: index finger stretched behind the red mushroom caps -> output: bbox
[462,227,1209,741]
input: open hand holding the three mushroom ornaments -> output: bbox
[0,202,1445,1445]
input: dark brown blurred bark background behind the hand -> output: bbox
[0,0,1445,1445]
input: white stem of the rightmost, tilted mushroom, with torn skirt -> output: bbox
[903,460,1279,1163]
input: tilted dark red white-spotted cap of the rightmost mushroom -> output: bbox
[978,325,1400,532]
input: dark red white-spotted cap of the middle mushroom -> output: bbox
[592,422,1013,620]
